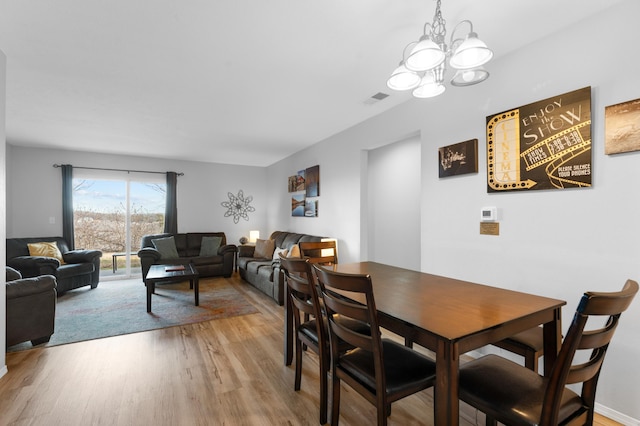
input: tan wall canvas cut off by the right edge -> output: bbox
[604,99,640,154]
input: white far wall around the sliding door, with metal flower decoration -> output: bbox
[3,145,268,245]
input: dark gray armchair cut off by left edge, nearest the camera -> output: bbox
[6,267,57,347]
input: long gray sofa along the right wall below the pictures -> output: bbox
[238,231,324,305]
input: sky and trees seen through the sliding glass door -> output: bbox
[73,179,166,271]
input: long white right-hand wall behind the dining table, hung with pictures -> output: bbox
[269,0,640,424]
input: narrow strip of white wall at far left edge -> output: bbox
[0,51,7,377]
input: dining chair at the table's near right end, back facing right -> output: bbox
[459,280,638,426]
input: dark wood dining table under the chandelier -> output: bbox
[284,262,566,426]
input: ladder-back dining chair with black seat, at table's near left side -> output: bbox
[313,264,436,426]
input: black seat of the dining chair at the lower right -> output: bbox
[460,355,587,426]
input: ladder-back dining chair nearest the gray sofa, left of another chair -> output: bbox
[280,255,329,424]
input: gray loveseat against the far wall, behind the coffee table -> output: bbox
[138,232,237,280]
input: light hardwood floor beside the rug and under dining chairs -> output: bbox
[0,276,616,426]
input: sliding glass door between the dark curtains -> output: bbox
[73,169,166,280]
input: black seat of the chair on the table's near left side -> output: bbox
[340,339,436,394]
